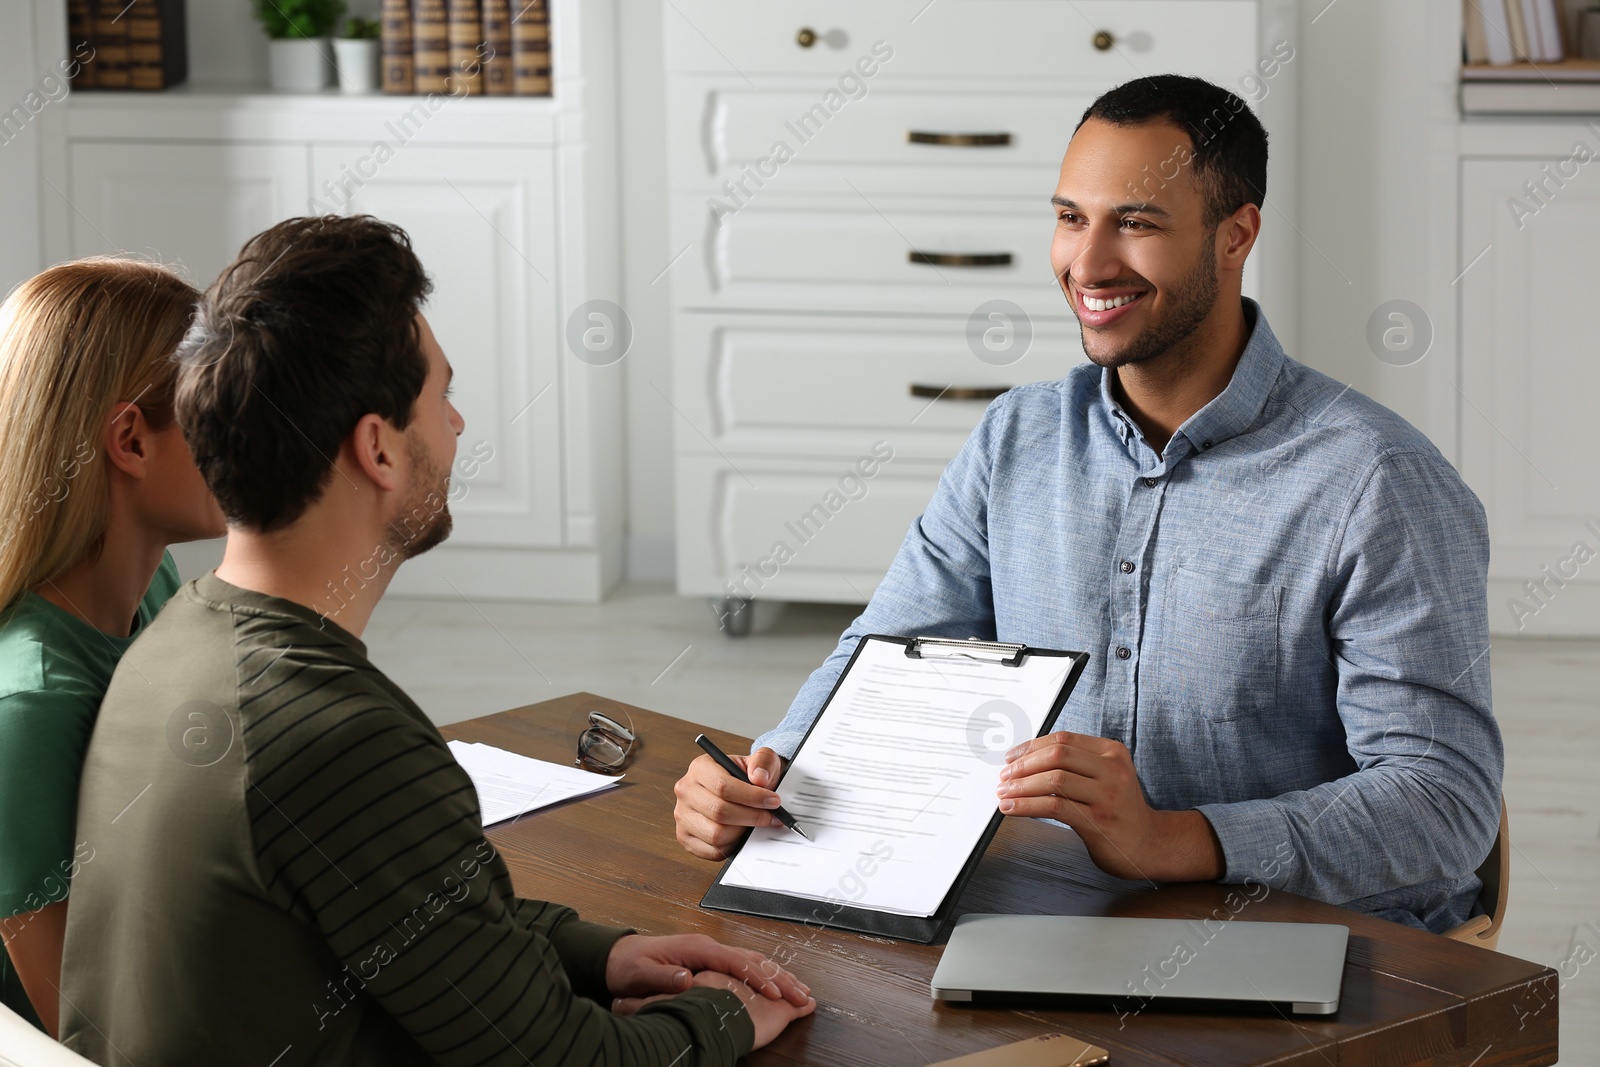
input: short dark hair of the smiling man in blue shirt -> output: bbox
[1078,74,1267,229]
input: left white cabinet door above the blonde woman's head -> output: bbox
[69,142,307,288]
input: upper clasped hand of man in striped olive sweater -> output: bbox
[605,934,816,1048]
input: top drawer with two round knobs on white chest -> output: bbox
[662,0,1256,86]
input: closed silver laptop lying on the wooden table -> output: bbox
[933,915,1350,1016]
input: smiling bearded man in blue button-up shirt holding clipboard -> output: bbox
[675,75,1504,931]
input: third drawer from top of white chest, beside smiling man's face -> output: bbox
[672,189,1072,318]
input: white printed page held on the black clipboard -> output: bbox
[722,640,1074,917]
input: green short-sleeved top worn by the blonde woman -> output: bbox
[0,553,179,1025]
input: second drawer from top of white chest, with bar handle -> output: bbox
[669,78,1094,200]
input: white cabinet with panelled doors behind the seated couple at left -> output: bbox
[35,0,624,600]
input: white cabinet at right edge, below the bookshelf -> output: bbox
[1458,139,1600,635]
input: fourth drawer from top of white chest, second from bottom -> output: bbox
[674,314,1085,464]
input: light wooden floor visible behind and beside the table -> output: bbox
[365,584,1600,1064]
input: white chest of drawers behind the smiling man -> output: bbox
[662,0,1273,617]
